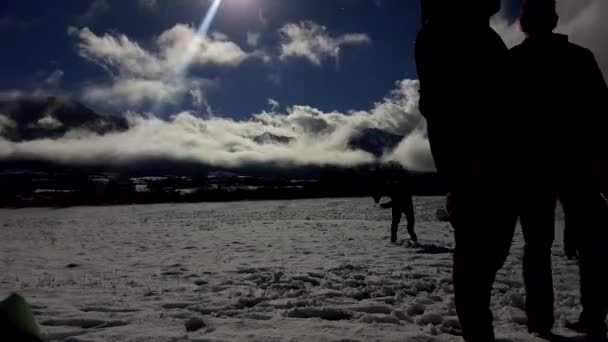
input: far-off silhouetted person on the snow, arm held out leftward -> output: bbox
[372,176,418,243]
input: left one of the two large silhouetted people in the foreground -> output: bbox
[416,0,518,342]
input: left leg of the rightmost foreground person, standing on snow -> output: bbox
[520,189,557,334]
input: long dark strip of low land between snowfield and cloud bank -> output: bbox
[0,160,446,208]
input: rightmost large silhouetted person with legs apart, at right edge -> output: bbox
[511,0,608,341]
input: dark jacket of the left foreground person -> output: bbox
[416,20,513,187]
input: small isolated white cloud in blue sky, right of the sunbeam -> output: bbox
[280,21,371,65]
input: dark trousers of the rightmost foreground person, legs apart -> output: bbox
[521,177,608,335]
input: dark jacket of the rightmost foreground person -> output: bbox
[510,34,608,172]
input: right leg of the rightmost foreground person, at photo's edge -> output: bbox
[561,190,608,341]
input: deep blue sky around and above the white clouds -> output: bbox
[0,0,524,118]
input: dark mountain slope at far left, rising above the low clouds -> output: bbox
[0,96,127,141]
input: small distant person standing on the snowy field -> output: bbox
[372,165,418,243]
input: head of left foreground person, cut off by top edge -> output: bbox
[421,0,501,23]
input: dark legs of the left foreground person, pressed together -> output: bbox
[448,192,517,342]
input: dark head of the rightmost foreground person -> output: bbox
[519,0,559,36]
